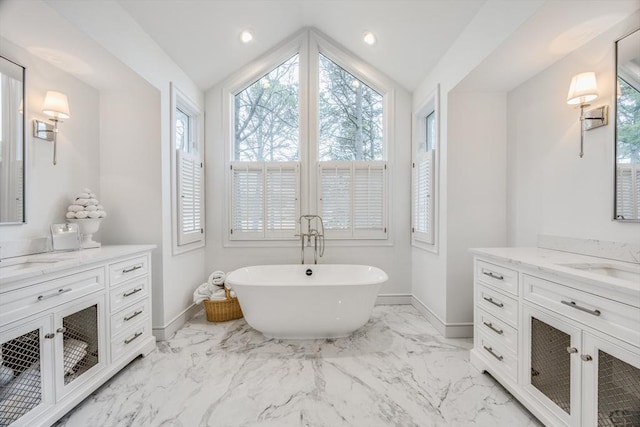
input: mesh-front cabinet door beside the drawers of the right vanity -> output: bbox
[522,305,581,426]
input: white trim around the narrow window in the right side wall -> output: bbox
[410,85,440,254]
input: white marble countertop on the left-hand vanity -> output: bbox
[0,245,156,287]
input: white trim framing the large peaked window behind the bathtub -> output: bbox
[222,29,395,247]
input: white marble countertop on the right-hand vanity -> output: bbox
[470,247,640,305]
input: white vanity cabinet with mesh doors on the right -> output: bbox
[471,248,640,427]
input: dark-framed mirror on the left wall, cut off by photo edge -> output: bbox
[0,56,25,224]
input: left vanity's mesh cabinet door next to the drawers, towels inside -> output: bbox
[55,294,106,400]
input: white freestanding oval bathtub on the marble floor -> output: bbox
[226,264,389,339]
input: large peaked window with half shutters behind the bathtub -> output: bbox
[225,30,392,240]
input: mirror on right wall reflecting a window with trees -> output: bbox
[613,29,640,221]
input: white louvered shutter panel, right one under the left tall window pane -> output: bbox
[265,163,300,237]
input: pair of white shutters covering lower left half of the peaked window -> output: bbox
[230,162,300,240]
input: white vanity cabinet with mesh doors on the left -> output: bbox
[0,246,155,427]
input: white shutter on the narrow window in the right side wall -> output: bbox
[412,150,434,244]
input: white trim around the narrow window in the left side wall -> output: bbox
[169,83,206,255]
